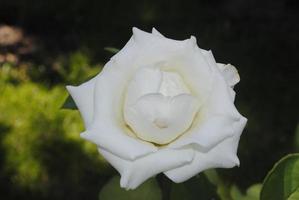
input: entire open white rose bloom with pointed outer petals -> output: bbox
[67,28,247,189]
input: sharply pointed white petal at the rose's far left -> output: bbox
[66,75,99,128]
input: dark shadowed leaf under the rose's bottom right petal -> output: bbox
[170,173,220,200]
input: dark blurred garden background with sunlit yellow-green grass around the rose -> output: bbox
[0,0,299,200]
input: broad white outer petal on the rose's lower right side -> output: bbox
[169,73,242,150]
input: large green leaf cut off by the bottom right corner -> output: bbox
[261,153,299,200]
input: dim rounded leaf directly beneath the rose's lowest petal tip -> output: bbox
[99,176,162,200]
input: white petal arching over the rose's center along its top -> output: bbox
[112,28,213,106]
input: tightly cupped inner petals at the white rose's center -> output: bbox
[124,67,199,144]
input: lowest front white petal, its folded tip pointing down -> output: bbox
[99,149,194,189]
